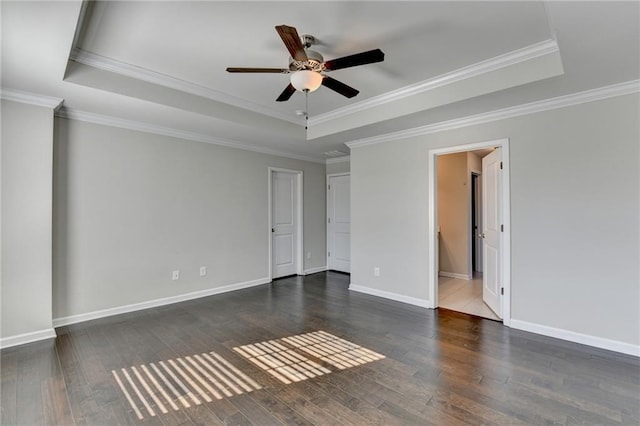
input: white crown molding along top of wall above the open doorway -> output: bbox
[345,80,640,149]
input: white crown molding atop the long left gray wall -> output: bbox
[56,108,324,164]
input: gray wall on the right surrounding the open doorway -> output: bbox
[351,94,640,345]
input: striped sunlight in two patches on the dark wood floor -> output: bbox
[111,331,385,420]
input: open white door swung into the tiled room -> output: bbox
[482,148,502,318]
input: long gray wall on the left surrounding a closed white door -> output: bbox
[53,119,326,318]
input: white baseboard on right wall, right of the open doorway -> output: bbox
[511,319,640,357]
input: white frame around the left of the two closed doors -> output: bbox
[267,167,304,280]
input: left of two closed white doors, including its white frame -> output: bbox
[268,167,303,279]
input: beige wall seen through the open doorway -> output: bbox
[437,152,471,279]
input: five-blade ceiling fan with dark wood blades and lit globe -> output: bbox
[227,25,384,102]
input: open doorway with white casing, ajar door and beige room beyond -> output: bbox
[429,139,510,325]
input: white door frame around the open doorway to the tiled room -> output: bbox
[427,138,511,326]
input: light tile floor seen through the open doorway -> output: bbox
[438,274,500,320]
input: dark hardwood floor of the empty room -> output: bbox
[1,272,640,425]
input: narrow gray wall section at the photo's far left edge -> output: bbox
[0,100,53,339]
